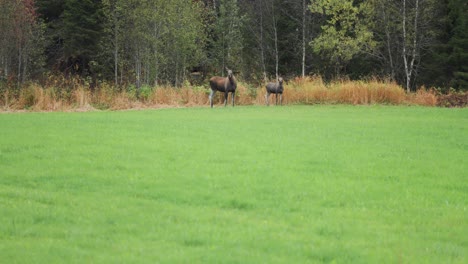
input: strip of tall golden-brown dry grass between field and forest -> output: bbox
[0,76,438,111]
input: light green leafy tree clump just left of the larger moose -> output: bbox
[105,0,205,86]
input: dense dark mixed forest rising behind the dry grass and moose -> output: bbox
[0,0,468,91]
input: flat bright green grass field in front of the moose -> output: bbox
[0,105,468,263]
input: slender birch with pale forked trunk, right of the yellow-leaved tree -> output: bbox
[372,0,444,92]
